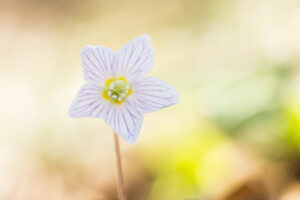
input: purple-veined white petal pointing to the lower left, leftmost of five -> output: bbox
[69,83,107,118]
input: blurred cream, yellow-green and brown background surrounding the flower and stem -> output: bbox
[0,0,300,200]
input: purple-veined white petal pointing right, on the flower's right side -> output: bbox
[128,77,178,113]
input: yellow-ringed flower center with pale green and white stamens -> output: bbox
[103,77,131,104]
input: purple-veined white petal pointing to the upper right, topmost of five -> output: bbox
[114,34,154,81]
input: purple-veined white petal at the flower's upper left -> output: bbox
[81,45,114,85]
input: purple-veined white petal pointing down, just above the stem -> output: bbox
[103,102,143,143]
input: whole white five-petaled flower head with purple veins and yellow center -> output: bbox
[69,34,178,143]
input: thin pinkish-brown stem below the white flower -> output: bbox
[114,133,126,200]
